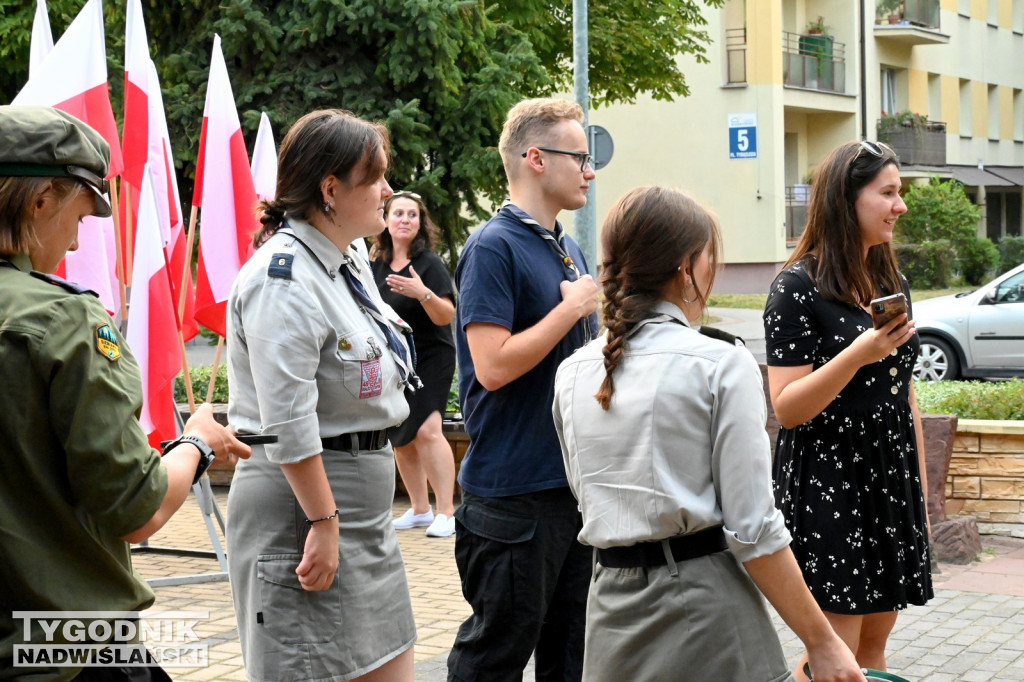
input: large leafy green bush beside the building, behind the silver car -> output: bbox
[896,177,998,285]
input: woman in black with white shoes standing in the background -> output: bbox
[372,191,455,538]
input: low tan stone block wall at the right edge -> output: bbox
[946,419,1024,538]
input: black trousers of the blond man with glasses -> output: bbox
[447,487,592,682]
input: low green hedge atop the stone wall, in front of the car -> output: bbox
[913,379,1024,420]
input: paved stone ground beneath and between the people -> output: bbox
[134,487,1024,682]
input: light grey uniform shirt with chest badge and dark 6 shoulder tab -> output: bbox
[227,218,409,464]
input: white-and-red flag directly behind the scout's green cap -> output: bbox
[11,0,124,312]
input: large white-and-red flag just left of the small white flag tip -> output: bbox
[193,36,259,336]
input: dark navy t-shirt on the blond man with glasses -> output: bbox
[455,201,597,498]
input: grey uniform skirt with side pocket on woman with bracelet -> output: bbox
[227,445,416,681]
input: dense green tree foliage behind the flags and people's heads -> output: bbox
[0,0,722,265]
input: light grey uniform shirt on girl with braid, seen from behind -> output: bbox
[552,301,791,562]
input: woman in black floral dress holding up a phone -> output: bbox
[764,141,933,679]
